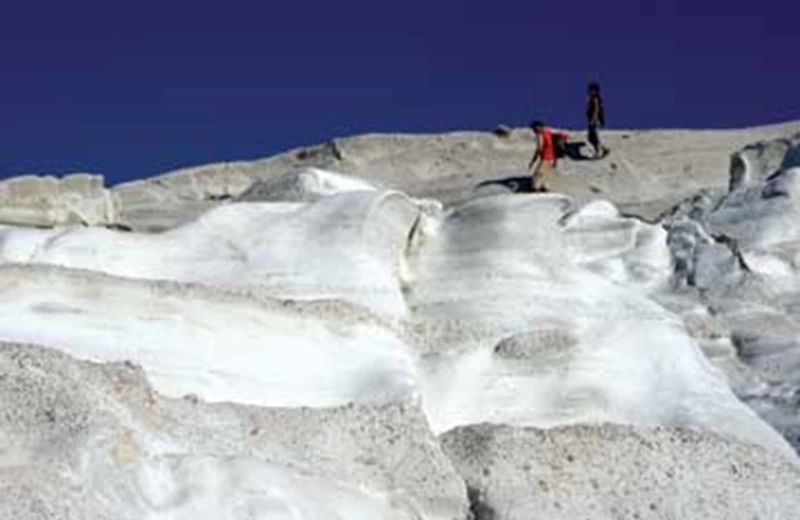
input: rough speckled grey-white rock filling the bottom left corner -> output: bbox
[0,343,467,520]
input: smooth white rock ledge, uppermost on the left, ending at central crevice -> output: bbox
[0,189,420,315]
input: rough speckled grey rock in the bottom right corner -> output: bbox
[441,424,800,520]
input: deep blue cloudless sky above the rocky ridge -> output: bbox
[0,0,800,183]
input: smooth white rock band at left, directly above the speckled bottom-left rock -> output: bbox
[0,266,417,407]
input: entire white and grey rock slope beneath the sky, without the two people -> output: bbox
[0,123,800,520]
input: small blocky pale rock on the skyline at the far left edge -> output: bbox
[0,173,115,227]
